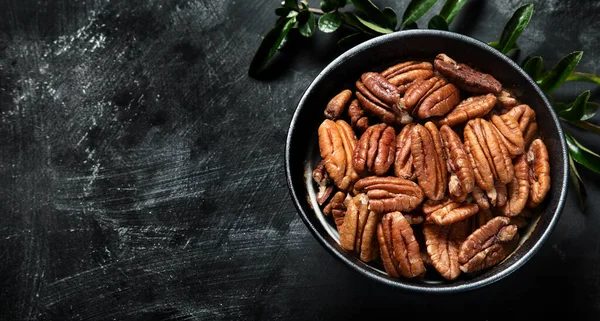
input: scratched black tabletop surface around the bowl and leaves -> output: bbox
[0,0,600,320]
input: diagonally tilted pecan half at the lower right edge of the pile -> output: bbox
[458,216,518,273]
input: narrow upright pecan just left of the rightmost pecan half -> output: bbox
[500,154,529,217]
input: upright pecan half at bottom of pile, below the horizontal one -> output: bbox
[377,212,426,278]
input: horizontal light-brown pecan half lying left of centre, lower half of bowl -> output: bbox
[354,176,424,213]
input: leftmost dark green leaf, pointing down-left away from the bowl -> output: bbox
[248,18,296,76]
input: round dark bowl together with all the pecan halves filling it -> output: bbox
[285,30,568,293]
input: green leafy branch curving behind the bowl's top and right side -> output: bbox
[248,0,600,211]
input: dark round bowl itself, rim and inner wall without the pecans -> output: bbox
[285,30,568,293]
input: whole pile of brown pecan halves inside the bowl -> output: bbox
[312,54,550,281]
